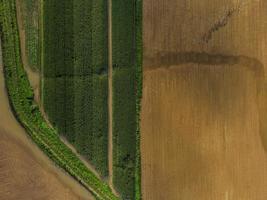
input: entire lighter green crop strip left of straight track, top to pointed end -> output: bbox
[73,0,108,176]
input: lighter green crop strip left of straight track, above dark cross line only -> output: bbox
[73,0,108,76]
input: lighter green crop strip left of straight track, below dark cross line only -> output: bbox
[74,75,108,177]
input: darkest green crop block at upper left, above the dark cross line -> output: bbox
[43,0,73,77]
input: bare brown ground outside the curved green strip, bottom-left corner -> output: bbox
[0,36,93,200]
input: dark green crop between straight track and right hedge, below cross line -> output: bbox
[113,69,136,199]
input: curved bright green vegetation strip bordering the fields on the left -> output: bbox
[0,0,118,200]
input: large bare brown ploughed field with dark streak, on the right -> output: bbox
[141,0,267,200]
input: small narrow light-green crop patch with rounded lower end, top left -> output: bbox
[19,0,40,71]
